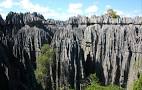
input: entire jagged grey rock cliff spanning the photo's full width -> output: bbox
[0,12,142,90]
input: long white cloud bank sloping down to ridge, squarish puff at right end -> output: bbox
[19,0,77,20]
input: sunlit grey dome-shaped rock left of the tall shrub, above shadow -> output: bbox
[13,25,51,65]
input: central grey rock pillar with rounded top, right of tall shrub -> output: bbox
[52,26,85,90]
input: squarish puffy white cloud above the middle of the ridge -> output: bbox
[68,3,83,15]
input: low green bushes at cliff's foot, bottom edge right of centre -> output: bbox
[85,74,124,90]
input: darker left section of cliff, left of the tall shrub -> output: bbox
[0,12,60,90]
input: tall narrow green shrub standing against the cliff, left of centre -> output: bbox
[35,44,53,89]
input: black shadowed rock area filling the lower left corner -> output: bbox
[0,43,42,90]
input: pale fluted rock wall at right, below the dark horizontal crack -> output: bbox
[84,24,142,87]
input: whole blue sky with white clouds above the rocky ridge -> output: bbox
[0,0,142,20]
